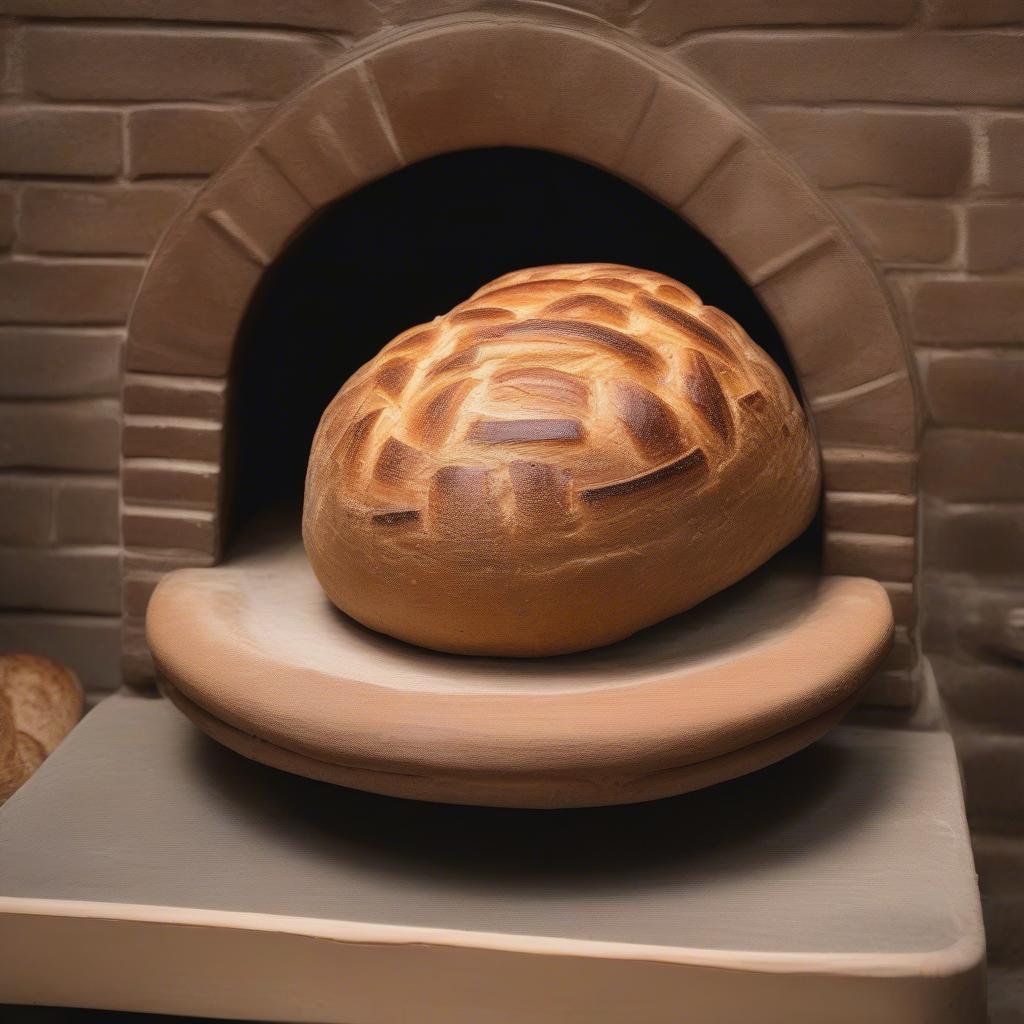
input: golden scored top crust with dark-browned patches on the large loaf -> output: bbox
[308,264,805,530]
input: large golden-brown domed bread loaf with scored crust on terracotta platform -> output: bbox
[303,264,819,656]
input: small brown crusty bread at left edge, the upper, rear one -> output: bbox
[0,654,83,756]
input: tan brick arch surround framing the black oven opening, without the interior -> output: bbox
[123,17,918,702]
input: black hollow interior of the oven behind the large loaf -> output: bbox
[227,148,820,551]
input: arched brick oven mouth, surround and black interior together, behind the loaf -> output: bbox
[122,23,920,708]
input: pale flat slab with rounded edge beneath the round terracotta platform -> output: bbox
[0,695,984,1024]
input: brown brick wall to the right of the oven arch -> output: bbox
[663,0,1024,999]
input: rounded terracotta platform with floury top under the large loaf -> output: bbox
[147,539,893,808]
